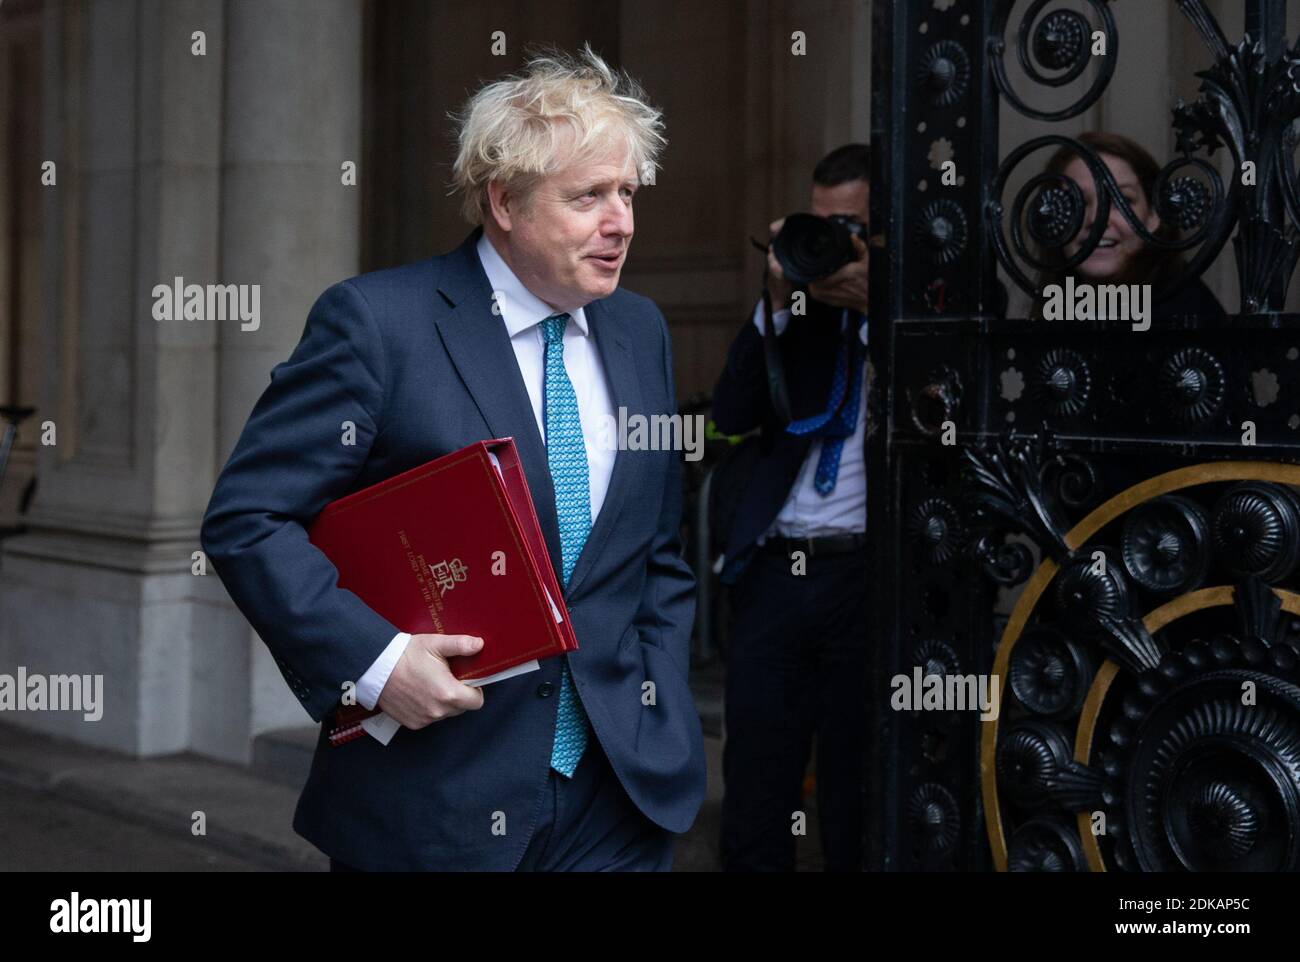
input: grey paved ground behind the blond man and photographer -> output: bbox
[0,725,820,871]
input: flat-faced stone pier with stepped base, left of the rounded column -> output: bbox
[0,0,221,754]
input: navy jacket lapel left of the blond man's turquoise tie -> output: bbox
[437,228,564,577]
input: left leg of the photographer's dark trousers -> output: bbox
[722,553,814,871]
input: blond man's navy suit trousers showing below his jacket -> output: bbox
[330,735,676,872]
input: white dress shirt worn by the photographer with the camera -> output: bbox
[754,300,867,545]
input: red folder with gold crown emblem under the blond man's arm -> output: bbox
[307,438,577,744]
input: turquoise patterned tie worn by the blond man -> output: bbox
[541,315,592,777]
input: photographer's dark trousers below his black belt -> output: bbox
[722,550,868,871]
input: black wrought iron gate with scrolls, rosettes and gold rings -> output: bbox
[867,0,1300,871]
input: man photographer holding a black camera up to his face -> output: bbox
[712,144,871,871]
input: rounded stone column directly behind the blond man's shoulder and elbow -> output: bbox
[201,0,368,757]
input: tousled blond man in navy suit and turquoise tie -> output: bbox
[202,49,705,871]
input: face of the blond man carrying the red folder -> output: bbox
[490,144,638,311]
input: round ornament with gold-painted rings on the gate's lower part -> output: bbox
[971,458,1300,871]
